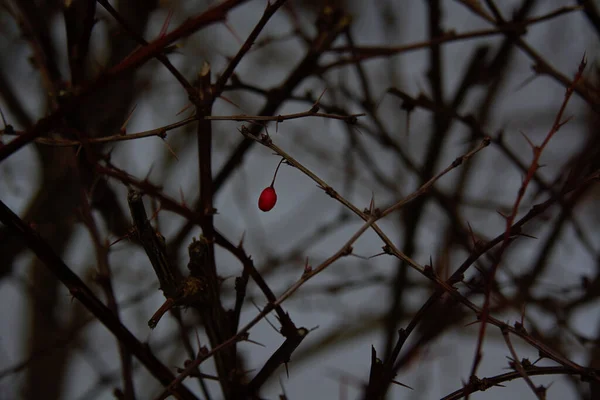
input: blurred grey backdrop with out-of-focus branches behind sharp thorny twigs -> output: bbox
[0,0,600,399]
